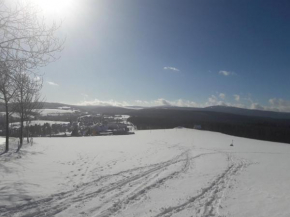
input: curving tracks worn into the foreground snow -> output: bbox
[0,144,249,217]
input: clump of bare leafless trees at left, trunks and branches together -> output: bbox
[0,0,65,151]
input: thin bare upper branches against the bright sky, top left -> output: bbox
[0,1,65,72]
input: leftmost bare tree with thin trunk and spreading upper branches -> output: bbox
[0,0,64,151]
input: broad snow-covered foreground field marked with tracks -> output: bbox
[0,129,290,217]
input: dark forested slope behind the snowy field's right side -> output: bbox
[128,109,290,143]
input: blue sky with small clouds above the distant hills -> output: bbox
[41,0,290,111]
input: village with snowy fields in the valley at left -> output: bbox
[0,106,136,137]
